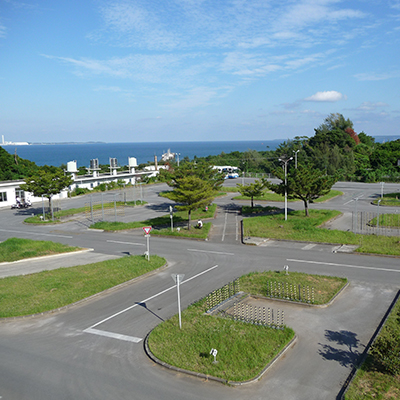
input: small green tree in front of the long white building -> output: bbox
[20,167,73,214]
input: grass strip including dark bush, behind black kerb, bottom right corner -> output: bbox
[345,294,400,400]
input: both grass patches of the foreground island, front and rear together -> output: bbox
[149,271,347,382]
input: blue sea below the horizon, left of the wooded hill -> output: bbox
[4,140,283,167]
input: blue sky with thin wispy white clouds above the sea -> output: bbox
[0,0,400,142]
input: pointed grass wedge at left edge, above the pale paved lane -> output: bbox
[0,238,81,262]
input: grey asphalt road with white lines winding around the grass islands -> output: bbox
[0,182,400,400]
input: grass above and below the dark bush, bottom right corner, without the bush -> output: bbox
[345,301,400,400]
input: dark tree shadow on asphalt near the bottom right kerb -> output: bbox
[318,330,364,368]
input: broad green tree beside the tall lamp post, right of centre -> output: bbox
[265,164,337,217]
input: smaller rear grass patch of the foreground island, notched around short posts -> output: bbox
[240,271,347,304]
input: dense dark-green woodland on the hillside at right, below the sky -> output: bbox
[198,114,400,182]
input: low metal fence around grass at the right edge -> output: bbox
[352,211,400,236]
